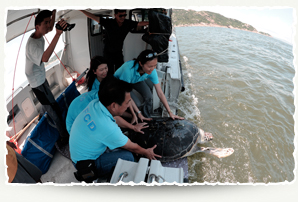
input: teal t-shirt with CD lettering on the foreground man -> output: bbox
[69,99,128,163]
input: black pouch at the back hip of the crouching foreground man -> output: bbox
[74,160,98,183]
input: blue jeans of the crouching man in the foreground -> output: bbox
[95,149,134,177]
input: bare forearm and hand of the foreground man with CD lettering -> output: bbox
[122,139,161,160]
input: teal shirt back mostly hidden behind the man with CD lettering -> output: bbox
[65,90,98,134]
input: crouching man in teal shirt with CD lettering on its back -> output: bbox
[69,78,161,180]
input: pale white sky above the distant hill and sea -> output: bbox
[191,6,297,44]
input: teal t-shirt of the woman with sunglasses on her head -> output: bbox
[114,60,159,84]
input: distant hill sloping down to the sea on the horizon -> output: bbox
[172,9,271,36]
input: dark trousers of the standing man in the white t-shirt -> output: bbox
[32,80,69,137]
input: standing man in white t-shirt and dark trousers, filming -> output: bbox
[25,10,69,144]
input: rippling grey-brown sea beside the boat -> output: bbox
[175,27,295,183]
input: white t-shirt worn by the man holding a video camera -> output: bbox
[25,35,46,88]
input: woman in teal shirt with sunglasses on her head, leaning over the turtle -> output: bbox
[114,50,183,119]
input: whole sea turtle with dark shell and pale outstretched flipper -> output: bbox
[125,118,234,162]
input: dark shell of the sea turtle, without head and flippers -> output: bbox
[127,118,200,162]
